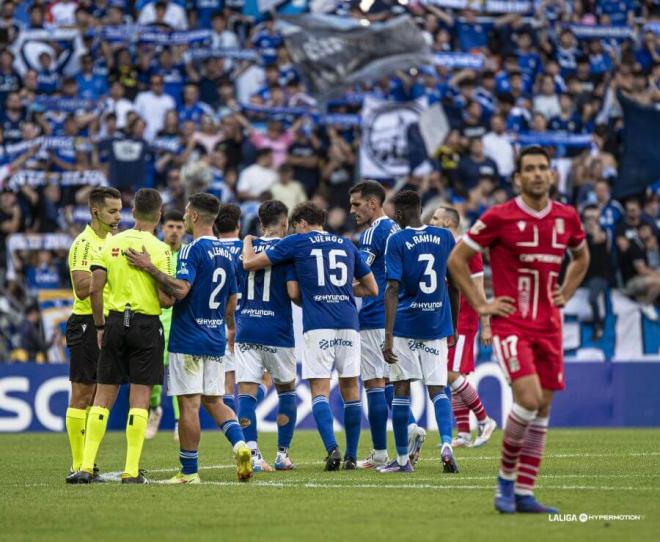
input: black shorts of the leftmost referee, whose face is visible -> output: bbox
[66,314,99,384]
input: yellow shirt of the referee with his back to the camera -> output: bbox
[92,229,173,316]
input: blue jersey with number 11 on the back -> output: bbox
[236,237,296,348]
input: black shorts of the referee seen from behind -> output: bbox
[98,311,165,386]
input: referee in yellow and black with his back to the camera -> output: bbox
[67,188,174,484]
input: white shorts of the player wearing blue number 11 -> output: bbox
[234,343,296,384]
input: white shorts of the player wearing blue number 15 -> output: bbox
[302,329,360,380]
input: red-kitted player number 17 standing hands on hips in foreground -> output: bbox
[449,146,589,513]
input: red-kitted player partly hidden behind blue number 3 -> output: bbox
[431,207,497,448]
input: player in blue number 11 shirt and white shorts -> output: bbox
[234,200,298,472]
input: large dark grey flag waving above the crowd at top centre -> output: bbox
[278,13,432,100]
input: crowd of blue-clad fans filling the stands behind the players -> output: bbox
[0,0,660,361]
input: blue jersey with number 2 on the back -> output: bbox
[169,237,237,356]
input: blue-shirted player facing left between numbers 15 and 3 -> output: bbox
[350,181,426,469]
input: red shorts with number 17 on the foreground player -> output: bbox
[493,322,564,390]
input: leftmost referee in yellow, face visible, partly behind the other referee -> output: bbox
[66,187,121,480]
